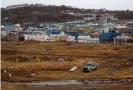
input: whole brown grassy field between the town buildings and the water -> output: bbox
[1,41,133,82]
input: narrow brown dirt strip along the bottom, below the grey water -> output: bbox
[1,85,133,90]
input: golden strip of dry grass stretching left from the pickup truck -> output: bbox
[1,59,96,71]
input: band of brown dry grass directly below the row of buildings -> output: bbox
[2,41,133,60]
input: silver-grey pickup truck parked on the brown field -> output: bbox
[83,62,99,72]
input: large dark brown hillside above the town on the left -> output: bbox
[1,6,82,23]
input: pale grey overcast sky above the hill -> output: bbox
[1,0,133,10]
